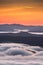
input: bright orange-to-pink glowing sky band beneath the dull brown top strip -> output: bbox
[0,0,43,25]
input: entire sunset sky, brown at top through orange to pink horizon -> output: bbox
[0,0,43,26]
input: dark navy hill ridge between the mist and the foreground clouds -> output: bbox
[0,32,43,47]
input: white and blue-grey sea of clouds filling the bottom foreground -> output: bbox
[0,43,43,65]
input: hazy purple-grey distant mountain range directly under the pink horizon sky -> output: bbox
[0,24,43,32]
